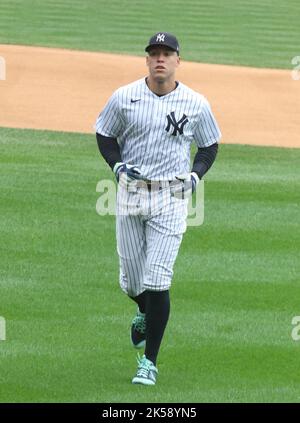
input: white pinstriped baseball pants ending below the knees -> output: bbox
[116,185,188,297]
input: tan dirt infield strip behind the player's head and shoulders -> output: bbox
[0,45,300,147]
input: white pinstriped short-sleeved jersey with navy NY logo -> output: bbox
[96,78,221,180]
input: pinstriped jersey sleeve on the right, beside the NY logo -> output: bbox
[194,98,221,147]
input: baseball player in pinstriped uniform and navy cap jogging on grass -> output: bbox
[96,32,221,385]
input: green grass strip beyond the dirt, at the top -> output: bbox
[0,0,300,69]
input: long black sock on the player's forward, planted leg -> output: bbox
[145,291,170,365]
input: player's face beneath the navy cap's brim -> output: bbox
[146,46,180,82]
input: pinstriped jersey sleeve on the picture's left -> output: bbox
[95,91,124,138]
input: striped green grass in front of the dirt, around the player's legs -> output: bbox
[0,129,300,403]
